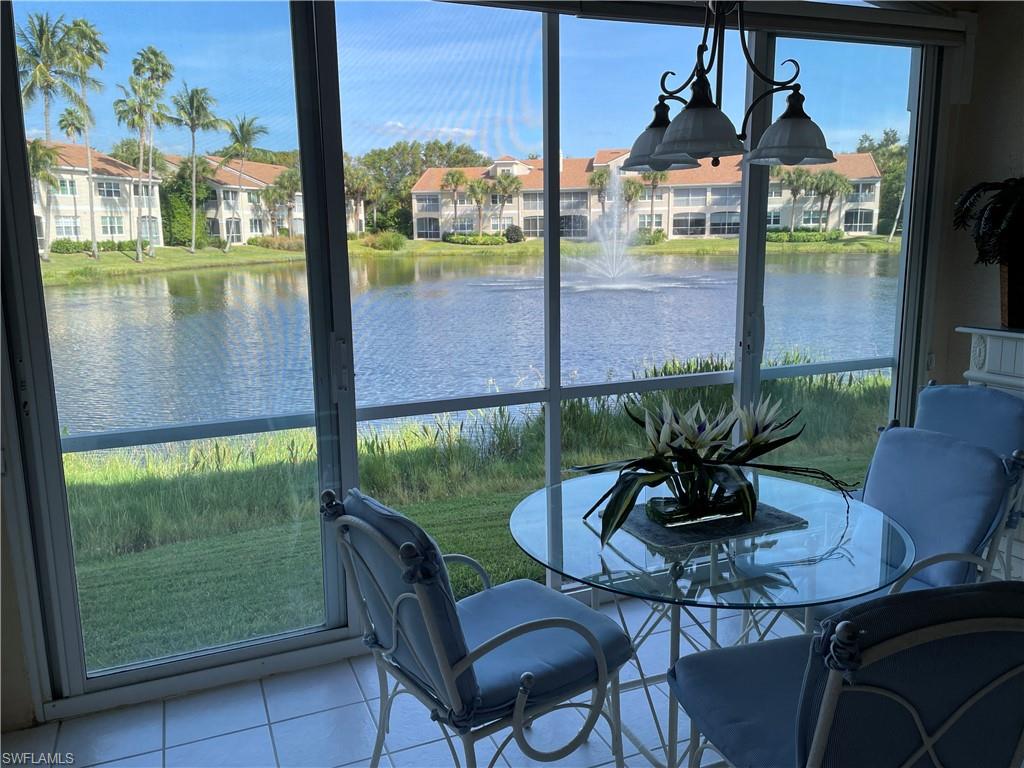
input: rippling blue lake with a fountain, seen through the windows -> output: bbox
[39,252,899,434]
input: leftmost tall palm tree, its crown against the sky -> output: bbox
[17,13,79,141]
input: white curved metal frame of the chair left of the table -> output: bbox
[334,514,624,768]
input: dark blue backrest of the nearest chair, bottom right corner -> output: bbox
[797,582,1024,768]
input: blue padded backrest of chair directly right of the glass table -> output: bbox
[864,427,1015,587]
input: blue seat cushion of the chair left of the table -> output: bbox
[458,580,633,724]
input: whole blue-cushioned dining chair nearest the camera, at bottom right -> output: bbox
[669,582,1024,768]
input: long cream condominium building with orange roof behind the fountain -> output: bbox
[412,150,882,240]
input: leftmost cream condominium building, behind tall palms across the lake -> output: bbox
[32,141,164,252]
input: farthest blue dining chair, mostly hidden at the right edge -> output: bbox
[913,382,1024,579]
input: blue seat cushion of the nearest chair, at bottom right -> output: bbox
[669,635,812,768]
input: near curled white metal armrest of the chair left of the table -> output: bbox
[452,616,608,762]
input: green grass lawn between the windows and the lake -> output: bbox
[65,361,889,670]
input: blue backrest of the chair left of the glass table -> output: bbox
[339,489,479,723]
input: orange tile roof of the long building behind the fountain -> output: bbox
[413,150,882,191]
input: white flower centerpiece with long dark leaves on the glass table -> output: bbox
[573,397,853,545]
